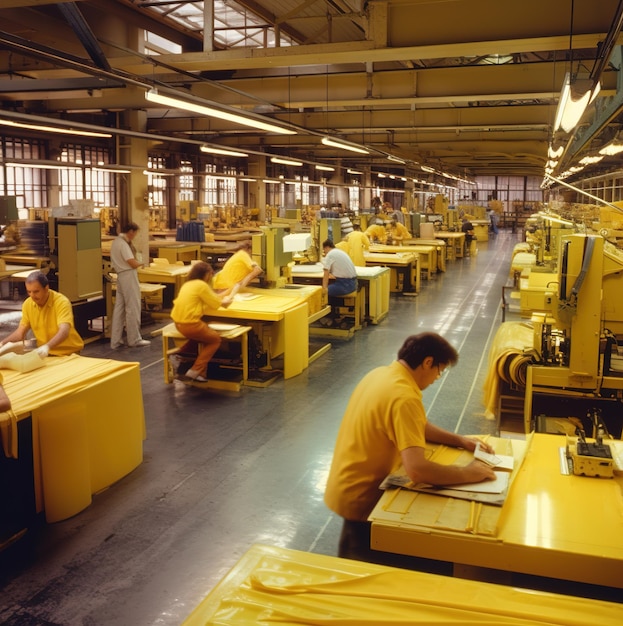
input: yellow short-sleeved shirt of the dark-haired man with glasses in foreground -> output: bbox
[324,361,426,522]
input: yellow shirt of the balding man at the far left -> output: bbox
[20,289,84,356]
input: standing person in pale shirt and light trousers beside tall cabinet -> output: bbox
[110,222,150,350]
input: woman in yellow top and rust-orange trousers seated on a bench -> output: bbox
[171,261,233,382]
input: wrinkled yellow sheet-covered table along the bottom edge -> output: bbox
[183,545,621,626]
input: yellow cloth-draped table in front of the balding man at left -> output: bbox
[0,354,145,522]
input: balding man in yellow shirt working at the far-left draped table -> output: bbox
[0,270,84,358]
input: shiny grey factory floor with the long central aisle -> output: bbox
[0,232,616,626]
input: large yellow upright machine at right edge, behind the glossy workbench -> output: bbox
[524,234,623,436]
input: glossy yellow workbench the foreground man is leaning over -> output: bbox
[369,433,623,588]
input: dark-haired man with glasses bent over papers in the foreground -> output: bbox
[324,332,495,564]
